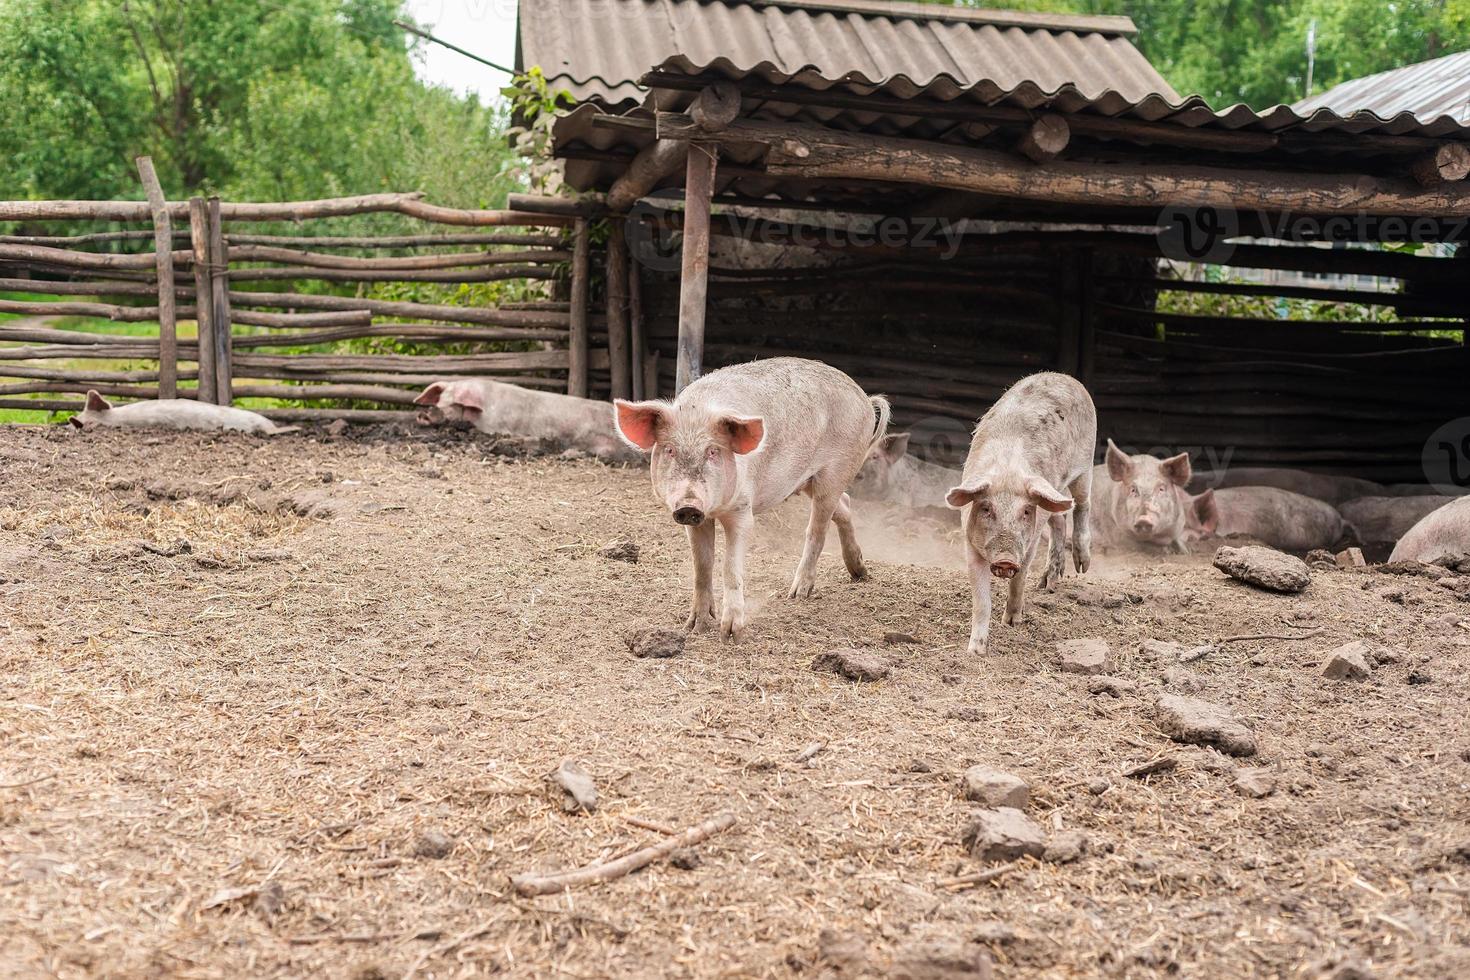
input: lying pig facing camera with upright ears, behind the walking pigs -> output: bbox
[1092,439,1191,554]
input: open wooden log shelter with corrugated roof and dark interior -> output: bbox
[517,0,1470,480]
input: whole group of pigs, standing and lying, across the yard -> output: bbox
[71,364,1470,664]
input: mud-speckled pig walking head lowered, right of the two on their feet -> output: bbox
[945,372,1098,654]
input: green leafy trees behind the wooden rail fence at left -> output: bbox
[0,0,516,207]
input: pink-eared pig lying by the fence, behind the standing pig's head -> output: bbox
[413,378,637,461]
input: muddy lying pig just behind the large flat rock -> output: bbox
[1189,486,1358,551]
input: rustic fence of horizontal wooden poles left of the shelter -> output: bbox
[0,157,645,417]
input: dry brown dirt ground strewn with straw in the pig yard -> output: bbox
[0,426,1470,980]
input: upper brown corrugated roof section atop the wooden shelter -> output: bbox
[519,0,1179,109]
